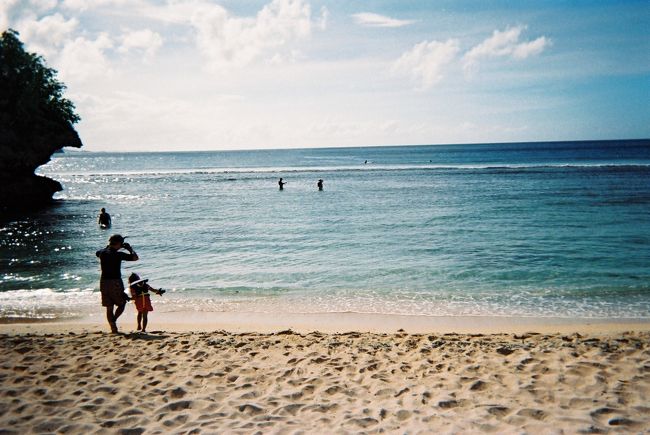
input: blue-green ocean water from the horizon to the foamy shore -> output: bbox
[0,140,650,319]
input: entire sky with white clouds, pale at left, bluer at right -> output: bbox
[0,0,650,151]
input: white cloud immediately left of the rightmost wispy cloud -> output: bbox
[393,39,460,89]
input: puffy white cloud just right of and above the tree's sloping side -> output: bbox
[57,33,113,81]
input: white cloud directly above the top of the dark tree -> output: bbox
[17,13,79,57]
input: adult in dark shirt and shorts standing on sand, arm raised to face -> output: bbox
[95,234,138,333]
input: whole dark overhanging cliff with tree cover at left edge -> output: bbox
[0,29,81,209]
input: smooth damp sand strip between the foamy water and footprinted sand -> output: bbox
[0,310,650,334]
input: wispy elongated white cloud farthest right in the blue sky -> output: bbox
[463,26,550,72]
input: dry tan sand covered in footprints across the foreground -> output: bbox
[0,325,650,434]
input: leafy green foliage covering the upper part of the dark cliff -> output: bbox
[0,29,80,131]
